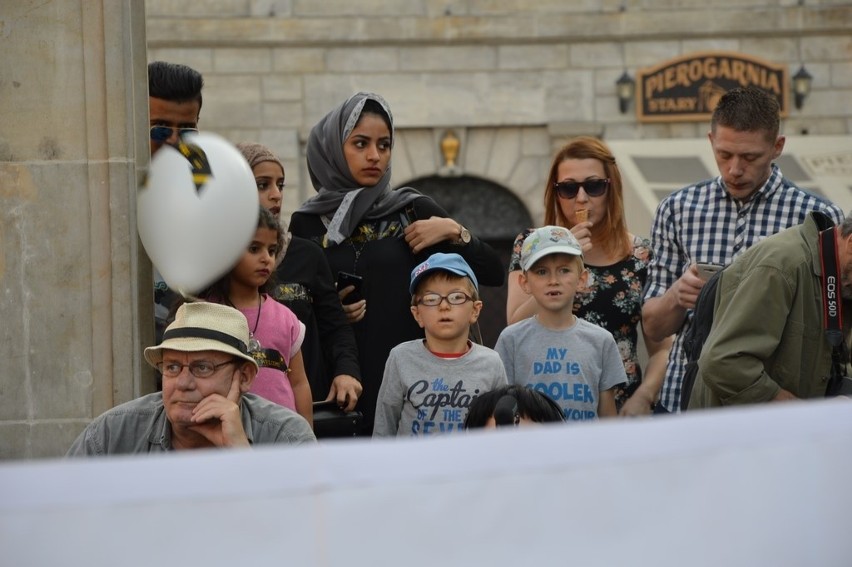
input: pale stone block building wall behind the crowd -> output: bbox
[147,0,852,224]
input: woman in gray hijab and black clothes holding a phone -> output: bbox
[290,92,504,435]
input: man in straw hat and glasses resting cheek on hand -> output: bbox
[67,302,316,456]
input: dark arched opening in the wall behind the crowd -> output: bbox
[403,175,533,347]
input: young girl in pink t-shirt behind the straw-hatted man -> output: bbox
[202,207,313,426]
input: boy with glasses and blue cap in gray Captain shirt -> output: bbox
[373,253,507,437]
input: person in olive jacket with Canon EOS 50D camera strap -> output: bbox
[689,212,852,410]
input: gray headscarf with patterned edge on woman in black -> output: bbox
[297,92,422,244]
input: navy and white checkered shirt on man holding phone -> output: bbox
[645,164,843,413]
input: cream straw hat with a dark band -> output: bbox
[145,301,257,367]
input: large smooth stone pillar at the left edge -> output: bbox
[0,0,153,459]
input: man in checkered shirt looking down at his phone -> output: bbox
[642,87,843,413]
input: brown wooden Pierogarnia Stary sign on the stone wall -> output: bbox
[636,51,790,122]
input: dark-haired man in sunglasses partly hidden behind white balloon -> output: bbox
[148,61,204,350]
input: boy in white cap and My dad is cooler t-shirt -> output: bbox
[494,226,627,421]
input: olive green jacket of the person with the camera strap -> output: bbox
[689,214,852,409]
